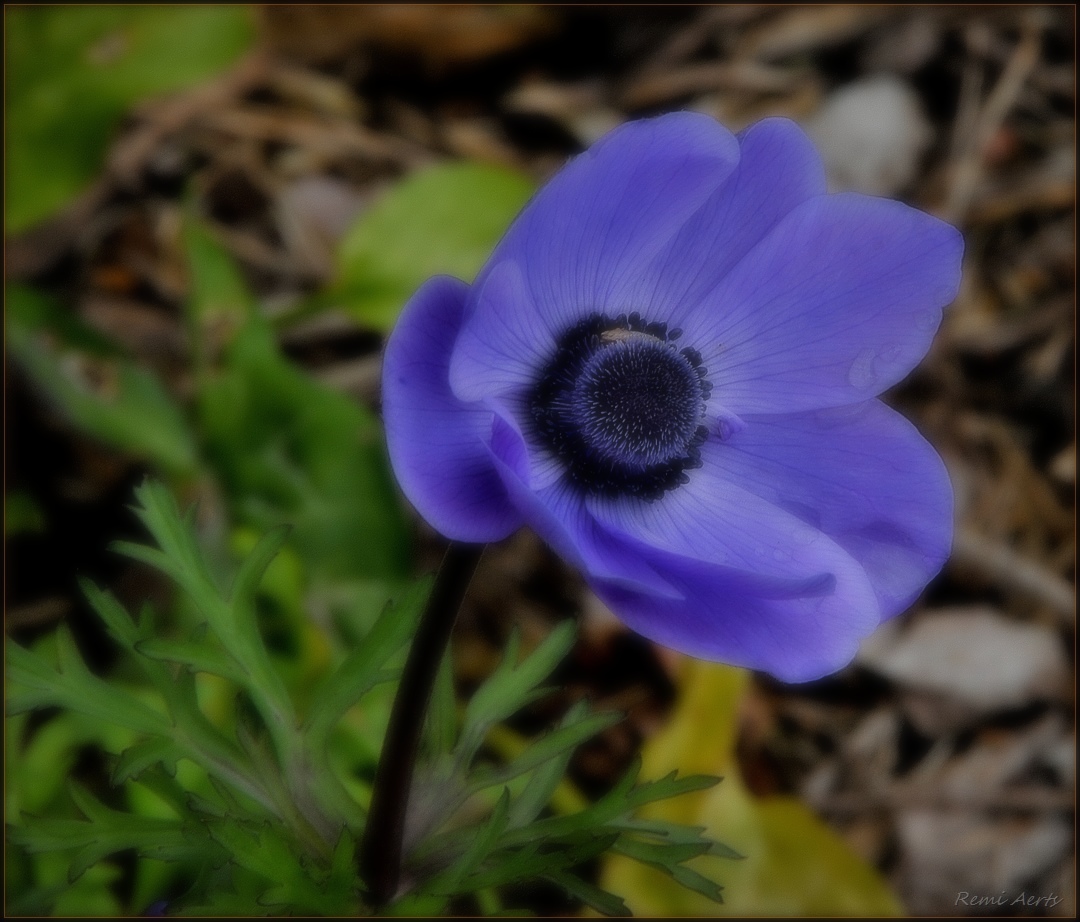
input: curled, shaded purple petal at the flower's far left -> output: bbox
[382,275,522,542]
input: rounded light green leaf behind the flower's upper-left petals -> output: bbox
[325,163,534,330]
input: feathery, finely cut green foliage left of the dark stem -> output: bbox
[8,483,408,914]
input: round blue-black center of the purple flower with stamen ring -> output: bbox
[529,313,712,500]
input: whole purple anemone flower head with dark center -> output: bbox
[382,112,963,681]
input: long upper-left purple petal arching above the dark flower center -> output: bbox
[453,112,739,399]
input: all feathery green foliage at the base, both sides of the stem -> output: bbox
[8,483,733,916]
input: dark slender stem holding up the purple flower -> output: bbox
[360,543,484,906]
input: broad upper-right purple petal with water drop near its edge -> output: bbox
[684,194,963,417]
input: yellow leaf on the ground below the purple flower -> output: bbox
[600,661,903,917]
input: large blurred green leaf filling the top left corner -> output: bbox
[4,5,254,234]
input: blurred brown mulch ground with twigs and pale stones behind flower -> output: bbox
[5,5,1076,916]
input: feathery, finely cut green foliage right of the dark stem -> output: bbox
[399,622,740,916]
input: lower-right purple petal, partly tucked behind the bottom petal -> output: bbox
[706,401,953,618]
